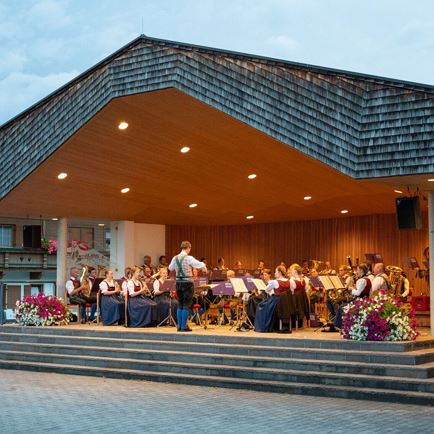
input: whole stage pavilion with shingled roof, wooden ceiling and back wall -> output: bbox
[0,35,434,328]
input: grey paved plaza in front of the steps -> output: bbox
[0,370,434,434]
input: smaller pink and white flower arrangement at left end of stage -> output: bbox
[15,292,72,326]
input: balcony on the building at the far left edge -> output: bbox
[0,247,56,271]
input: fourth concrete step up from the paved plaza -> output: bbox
[0,327,434,366]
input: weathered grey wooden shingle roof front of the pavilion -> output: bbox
[0,35,434,198]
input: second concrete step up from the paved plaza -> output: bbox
[0,350,434,396]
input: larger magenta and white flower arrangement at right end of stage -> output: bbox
[342,291,419,341]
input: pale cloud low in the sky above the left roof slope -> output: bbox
[0,71,78,125]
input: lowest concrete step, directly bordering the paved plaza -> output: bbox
[0,360,434,406]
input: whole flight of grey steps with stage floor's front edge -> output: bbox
[0,325,434,406]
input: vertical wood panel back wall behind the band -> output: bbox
[166,214,428,292]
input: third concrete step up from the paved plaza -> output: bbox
[0,341,434,378]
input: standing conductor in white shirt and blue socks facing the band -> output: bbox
[169,241,207,332]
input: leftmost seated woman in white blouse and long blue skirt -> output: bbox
[99,269,125,325]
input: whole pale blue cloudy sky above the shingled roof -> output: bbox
[0,0,434,124]
